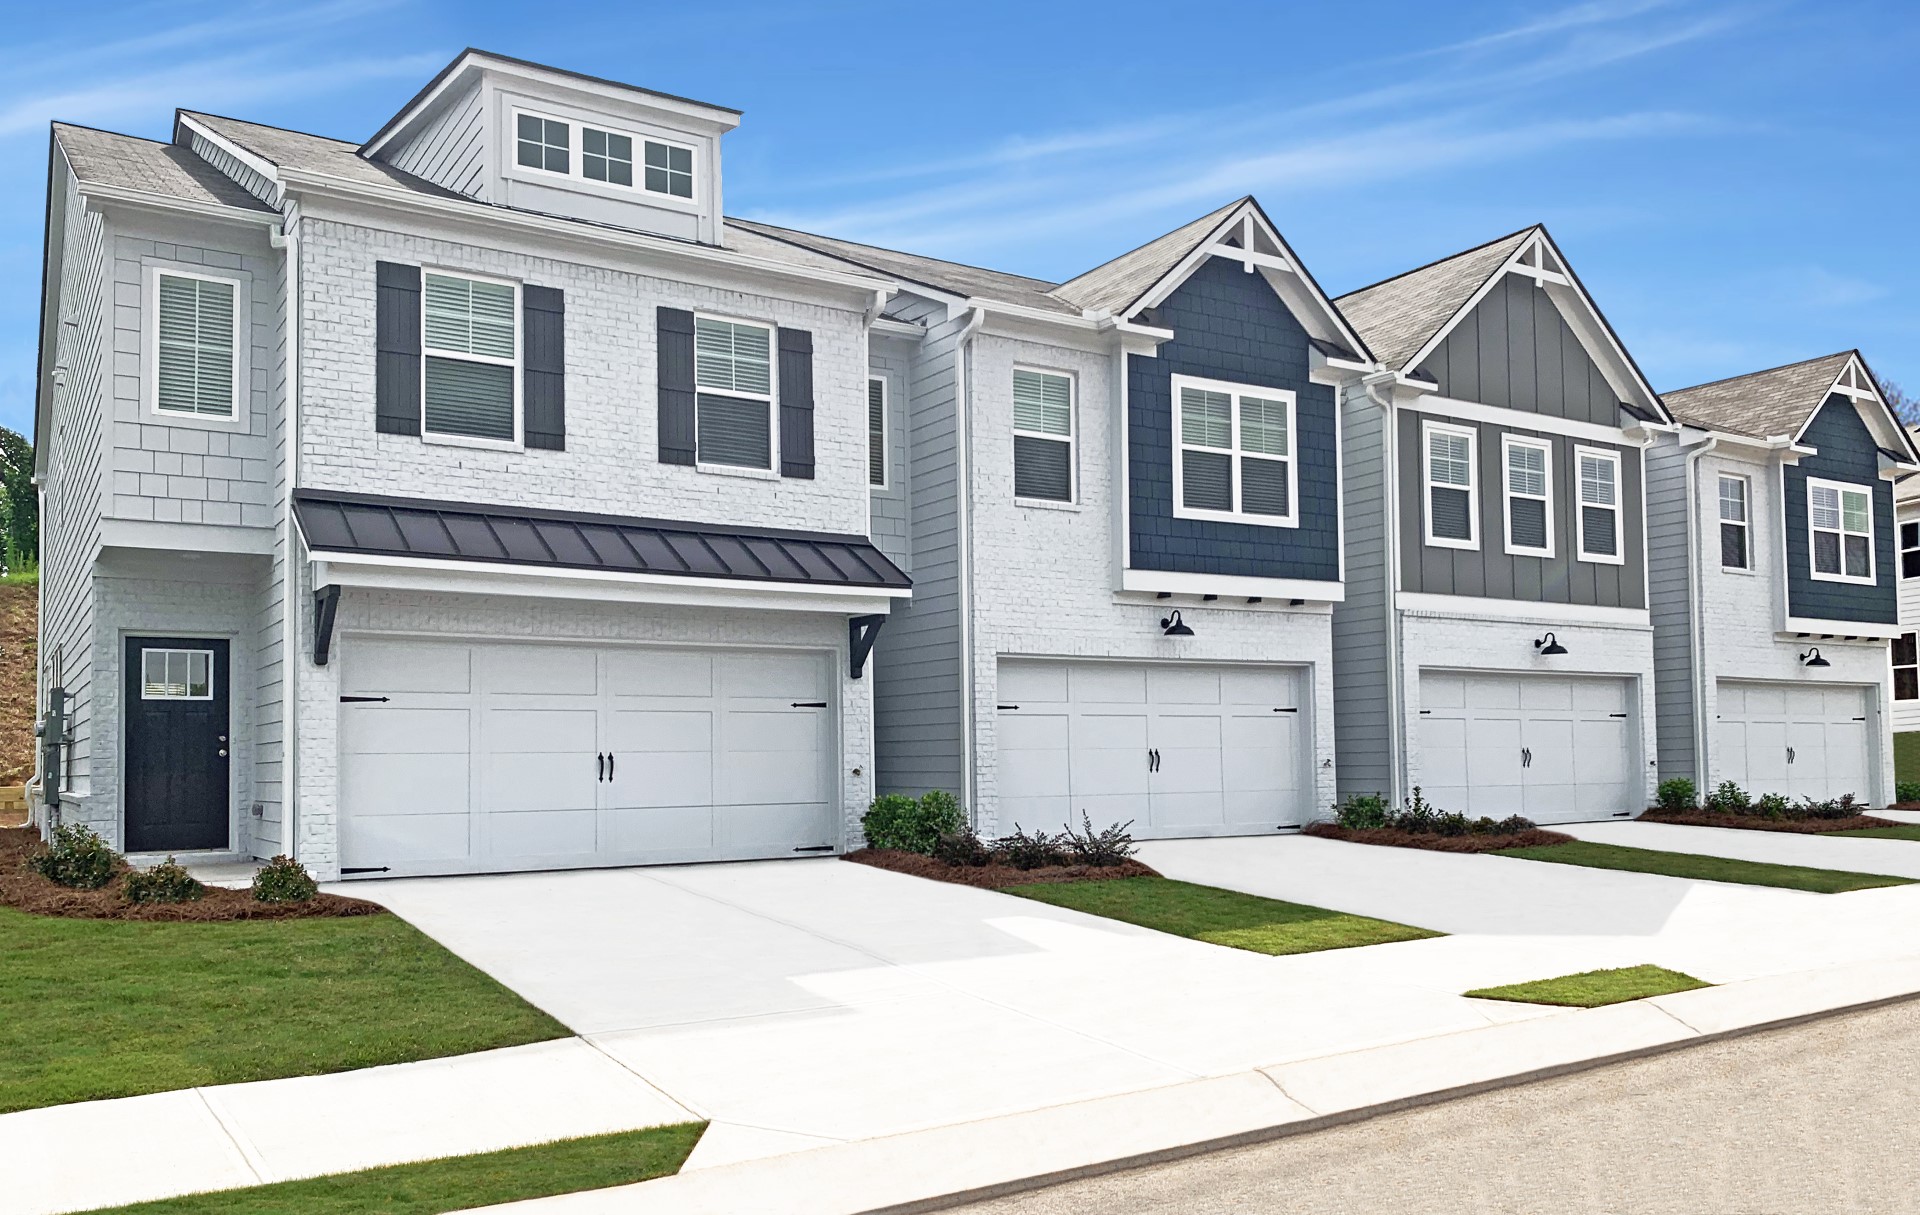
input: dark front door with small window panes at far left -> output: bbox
[127,637,232,852]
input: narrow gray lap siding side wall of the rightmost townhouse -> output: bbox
[1647,436,1699,783]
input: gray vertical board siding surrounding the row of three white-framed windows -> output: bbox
[1398,409,1647,608]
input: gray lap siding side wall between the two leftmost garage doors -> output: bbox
[874,321,968,793]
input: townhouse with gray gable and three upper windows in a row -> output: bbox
[1334,226,1670,822]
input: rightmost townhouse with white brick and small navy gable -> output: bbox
[1647,351,1920,804]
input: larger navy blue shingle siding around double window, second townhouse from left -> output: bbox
[1127,257,1340,582]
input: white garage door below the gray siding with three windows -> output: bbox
[1417,672,1645,823]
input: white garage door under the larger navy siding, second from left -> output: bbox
[998,658,1311,839]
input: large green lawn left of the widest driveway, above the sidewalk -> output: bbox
[0,908,566,1113]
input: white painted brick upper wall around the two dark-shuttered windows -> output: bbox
[300,217,868,534]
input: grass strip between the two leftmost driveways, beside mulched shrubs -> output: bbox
[1004,877,1446,954]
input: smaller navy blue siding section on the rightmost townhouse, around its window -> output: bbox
[1786,395,1899,624]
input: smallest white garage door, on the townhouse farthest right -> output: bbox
[1711,679,1874,800]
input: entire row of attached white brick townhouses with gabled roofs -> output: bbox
[36,52,1920,877]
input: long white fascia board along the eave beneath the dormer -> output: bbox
[284,169,899,307]
